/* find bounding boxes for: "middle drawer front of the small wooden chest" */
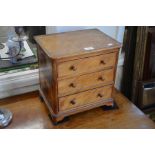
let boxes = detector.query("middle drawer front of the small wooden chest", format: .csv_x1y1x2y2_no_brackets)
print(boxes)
58,68,114,96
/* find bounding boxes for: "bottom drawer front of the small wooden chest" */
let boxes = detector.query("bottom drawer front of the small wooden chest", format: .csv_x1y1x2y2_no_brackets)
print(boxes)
59,85,112,111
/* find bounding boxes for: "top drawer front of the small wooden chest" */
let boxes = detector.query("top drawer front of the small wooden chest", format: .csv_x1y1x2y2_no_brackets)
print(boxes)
58,52,117,77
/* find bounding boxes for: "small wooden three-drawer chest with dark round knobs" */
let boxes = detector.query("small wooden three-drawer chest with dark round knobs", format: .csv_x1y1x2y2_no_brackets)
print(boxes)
35,29,120,123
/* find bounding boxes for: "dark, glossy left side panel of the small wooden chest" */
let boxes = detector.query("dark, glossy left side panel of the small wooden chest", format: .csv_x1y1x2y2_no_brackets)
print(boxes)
38,47,58,113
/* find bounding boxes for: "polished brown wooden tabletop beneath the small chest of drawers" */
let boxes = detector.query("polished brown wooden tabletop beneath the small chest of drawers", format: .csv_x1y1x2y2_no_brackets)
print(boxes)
0,91,155,129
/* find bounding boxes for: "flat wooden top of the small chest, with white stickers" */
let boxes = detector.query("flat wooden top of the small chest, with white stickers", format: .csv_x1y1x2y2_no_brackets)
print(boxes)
35,29,121,59
